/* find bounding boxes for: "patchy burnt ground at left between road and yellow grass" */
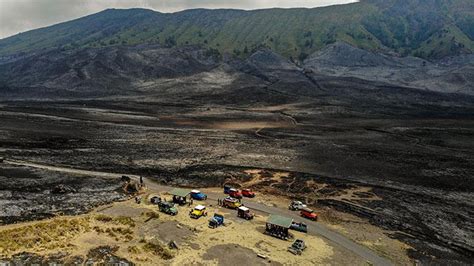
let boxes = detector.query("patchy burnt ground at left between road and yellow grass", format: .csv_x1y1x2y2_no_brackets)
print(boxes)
0,165,127,224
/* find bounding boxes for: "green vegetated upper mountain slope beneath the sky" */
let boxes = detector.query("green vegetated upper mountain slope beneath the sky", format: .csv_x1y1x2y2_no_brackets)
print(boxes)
0,0,474,60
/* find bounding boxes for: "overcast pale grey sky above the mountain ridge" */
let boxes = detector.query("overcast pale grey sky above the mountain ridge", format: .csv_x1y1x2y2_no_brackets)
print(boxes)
0,0,356,38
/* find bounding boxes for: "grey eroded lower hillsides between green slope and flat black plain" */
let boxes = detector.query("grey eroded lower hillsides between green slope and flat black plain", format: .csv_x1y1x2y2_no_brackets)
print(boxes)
0,42,474,98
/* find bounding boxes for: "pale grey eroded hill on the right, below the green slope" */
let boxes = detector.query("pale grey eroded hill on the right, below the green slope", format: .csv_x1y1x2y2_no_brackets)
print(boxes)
304,43,474,95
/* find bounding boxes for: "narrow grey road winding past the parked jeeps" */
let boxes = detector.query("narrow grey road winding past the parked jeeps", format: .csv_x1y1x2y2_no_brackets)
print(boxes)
4,160,393,265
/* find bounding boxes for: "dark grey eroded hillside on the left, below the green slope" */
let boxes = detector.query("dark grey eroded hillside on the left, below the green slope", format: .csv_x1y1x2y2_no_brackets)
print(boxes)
0,46,218,97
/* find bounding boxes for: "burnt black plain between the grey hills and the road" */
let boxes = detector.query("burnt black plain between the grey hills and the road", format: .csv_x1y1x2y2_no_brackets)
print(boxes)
0,93,474,262
